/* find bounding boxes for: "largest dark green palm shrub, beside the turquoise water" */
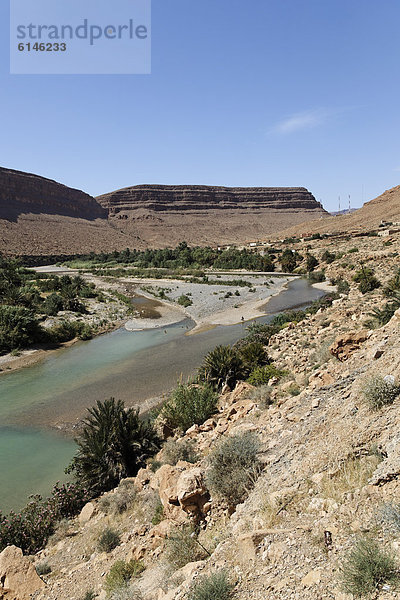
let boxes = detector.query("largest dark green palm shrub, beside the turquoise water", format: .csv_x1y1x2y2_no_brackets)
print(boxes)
69,398,160,496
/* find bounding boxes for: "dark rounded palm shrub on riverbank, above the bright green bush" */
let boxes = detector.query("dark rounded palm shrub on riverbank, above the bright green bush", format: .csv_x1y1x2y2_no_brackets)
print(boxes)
199,345,246,390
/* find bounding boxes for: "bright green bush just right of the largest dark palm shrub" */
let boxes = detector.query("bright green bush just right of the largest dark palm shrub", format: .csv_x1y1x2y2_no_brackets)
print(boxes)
161,383,218,431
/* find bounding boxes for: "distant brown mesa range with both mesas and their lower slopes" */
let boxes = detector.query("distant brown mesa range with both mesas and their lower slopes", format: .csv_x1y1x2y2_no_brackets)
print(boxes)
0,168,328,255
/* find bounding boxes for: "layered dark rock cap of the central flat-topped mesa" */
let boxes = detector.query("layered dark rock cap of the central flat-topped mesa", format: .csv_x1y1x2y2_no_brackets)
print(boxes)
97,185,326,218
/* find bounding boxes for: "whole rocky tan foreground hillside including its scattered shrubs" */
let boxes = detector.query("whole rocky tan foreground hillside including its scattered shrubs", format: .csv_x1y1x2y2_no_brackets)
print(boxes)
0,234,400,600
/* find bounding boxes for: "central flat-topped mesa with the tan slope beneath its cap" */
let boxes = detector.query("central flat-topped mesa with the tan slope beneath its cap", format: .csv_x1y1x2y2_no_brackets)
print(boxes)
97,185,328,247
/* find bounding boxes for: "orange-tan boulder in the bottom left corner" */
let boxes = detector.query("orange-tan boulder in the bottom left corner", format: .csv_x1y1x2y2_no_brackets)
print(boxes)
0,546,45,600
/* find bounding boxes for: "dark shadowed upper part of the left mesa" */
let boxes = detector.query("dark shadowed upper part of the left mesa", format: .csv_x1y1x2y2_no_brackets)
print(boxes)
0,167,107,221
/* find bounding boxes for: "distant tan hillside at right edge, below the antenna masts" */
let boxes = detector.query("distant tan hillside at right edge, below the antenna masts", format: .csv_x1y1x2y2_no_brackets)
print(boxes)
276,185,400,237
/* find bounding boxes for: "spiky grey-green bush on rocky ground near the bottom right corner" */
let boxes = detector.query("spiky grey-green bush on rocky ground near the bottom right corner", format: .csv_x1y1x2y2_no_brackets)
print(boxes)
340,538,399,598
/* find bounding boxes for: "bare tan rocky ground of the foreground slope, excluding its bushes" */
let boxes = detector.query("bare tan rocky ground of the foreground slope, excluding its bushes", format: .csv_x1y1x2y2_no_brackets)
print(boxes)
0,235,400,600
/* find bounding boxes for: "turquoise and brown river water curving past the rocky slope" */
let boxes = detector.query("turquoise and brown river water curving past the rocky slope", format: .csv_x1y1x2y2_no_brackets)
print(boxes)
0,279,324,513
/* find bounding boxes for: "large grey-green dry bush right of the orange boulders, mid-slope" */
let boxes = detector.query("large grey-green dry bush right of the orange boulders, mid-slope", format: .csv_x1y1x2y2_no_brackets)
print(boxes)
207,432,261,506
